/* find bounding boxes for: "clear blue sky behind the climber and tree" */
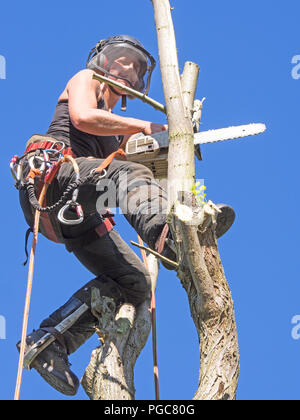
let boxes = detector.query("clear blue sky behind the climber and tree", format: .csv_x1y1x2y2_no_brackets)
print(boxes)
0,0,300,400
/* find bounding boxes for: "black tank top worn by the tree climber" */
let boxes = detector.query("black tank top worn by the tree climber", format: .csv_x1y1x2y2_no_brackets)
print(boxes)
46,99,123,158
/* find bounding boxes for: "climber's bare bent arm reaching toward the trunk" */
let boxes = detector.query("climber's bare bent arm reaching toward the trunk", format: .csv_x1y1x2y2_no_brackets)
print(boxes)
67,70,166,136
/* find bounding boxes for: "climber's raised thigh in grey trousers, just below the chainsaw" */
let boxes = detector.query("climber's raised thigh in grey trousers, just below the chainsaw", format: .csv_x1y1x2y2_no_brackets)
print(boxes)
52,158,167,248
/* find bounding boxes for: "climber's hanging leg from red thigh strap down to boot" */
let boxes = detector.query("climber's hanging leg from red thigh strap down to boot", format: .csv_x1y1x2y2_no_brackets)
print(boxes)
17,227,151,395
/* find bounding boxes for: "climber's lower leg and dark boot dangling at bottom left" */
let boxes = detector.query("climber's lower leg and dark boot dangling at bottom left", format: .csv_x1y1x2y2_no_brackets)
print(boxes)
17,275,123,395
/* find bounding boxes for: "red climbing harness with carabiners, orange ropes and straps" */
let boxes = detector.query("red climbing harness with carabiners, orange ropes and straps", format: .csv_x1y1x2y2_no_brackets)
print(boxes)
10,135,159,400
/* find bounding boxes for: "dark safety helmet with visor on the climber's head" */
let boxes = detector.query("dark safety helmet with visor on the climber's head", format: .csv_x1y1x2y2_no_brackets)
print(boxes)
86,35,156,97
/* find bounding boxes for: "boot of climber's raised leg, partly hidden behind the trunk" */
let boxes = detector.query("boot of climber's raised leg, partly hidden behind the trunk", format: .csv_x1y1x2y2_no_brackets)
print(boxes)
155,204,235,270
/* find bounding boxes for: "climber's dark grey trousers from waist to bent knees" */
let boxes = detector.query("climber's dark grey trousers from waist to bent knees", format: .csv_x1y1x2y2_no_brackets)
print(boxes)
20,158,167,305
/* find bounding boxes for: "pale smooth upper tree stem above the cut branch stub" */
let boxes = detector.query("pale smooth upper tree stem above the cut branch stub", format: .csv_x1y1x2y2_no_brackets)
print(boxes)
152,0,195,212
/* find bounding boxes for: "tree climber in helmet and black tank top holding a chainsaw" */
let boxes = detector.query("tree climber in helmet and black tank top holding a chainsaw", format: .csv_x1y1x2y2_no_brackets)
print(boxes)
17,35,234,395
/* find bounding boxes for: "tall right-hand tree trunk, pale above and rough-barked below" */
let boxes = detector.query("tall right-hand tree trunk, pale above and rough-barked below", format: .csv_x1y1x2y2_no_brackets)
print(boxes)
152,0,239,400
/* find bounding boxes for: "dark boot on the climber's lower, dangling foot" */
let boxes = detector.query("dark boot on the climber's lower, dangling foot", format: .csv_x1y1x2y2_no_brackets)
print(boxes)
17,329,79,395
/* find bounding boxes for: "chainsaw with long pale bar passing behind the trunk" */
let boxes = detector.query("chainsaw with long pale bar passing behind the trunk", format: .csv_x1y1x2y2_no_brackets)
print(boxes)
125,124,266,179
